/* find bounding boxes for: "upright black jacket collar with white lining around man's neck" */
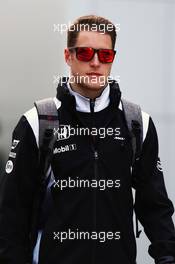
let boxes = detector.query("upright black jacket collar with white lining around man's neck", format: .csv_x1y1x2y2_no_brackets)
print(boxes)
57,77,121,113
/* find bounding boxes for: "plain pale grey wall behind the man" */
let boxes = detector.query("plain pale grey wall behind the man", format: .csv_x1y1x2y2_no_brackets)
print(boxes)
0,0,175,264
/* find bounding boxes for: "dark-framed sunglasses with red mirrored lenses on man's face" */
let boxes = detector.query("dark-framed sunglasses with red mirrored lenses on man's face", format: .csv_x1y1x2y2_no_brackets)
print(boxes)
69,47,116,63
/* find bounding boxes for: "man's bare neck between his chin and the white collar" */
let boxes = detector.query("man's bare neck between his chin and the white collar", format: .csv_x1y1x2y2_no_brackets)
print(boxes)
70,83,107,99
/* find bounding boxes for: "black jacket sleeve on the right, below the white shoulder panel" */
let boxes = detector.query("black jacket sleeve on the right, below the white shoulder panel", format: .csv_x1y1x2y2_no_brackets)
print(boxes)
133,118,175,264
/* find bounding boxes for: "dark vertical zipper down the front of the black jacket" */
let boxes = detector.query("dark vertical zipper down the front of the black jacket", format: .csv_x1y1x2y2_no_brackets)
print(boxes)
90,99,99,264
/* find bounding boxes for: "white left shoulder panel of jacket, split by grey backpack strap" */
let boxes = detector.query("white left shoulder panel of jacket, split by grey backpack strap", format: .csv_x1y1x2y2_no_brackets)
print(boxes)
23,97,61,147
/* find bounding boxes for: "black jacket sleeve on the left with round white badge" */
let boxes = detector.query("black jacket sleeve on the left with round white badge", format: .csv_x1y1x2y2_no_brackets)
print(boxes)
0,116,38,264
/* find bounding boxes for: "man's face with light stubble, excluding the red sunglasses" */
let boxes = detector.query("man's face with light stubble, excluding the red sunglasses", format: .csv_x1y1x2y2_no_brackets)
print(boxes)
65,31,112,91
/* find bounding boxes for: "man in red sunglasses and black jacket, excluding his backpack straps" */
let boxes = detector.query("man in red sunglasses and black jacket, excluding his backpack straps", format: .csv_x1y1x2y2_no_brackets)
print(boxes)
0,16,175,264
